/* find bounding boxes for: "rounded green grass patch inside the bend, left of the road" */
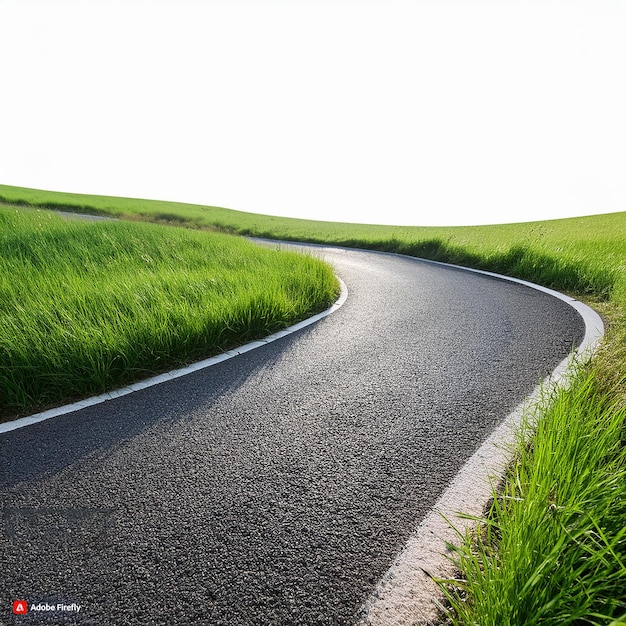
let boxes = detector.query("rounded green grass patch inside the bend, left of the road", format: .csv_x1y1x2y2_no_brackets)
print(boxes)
0,206,338,418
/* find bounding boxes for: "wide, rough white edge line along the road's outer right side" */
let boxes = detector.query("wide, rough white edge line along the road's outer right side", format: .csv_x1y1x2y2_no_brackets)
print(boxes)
358,264,604,626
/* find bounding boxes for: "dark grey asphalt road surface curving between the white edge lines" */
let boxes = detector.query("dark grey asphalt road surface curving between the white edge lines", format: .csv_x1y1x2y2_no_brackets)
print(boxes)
0,249,584,626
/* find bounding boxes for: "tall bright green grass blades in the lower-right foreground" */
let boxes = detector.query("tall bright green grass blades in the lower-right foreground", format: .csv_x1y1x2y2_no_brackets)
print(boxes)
443,371,626,626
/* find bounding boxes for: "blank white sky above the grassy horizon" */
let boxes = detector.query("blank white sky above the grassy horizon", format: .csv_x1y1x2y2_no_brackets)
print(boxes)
0,0,626,225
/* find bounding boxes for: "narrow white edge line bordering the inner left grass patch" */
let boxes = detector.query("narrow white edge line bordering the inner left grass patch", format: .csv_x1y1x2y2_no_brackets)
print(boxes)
0,278,348,433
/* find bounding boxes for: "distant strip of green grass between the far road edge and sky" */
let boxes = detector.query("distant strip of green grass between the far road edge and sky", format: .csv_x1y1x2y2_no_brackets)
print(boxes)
0,185,626,300
